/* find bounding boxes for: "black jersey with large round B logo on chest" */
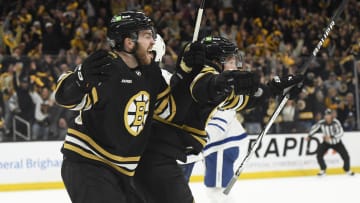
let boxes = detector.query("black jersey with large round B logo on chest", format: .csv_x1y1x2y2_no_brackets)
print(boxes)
56,53,171,176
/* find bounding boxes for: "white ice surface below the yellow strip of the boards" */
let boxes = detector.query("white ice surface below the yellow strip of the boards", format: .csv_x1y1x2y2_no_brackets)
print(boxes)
0,174,360,203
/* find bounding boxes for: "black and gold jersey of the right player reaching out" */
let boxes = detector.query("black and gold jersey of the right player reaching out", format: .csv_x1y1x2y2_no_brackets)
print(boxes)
148,65,249,161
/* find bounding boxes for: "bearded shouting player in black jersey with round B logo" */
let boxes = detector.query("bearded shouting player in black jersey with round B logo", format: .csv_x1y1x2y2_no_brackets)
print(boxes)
56,11,205,203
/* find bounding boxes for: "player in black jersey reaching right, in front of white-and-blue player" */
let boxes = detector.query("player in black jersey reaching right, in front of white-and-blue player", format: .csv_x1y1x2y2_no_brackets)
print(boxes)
135,37,302,203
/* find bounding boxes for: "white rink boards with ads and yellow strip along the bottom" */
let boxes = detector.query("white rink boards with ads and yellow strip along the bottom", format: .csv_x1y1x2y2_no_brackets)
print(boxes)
0,133,360,191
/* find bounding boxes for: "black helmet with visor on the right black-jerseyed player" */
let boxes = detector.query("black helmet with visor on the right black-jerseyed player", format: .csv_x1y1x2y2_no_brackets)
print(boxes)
201,36,242,67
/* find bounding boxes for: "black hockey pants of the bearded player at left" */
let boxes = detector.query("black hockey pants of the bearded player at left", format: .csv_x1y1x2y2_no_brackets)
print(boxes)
61,158,143,203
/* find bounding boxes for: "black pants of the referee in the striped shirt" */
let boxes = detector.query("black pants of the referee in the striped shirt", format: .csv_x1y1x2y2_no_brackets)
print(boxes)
316,141,350,171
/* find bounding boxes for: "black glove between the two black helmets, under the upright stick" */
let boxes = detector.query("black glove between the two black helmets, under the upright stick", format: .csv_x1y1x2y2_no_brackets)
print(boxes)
180,41,206,74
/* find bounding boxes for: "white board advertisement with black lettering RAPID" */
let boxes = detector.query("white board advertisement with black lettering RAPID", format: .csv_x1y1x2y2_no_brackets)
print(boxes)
193,132,360,176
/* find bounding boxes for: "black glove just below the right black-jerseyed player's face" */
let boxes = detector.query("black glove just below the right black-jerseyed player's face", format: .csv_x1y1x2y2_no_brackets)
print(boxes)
232,71,260,96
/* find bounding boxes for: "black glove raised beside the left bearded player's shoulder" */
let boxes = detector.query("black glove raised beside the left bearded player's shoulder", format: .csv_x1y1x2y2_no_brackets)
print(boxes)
75,50,112,92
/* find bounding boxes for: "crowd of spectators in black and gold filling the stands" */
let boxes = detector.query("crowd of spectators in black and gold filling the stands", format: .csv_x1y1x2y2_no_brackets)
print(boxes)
0,0,360,140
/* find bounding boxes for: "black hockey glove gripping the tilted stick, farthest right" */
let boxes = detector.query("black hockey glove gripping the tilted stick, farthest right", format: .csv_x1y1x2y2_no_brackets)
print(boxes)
268,75,304,99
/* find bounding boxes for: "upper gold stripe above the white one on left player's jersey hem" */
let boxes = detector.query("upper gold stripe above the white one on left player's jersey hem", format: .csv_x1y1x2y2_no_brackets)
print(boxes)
68,128,140,162
